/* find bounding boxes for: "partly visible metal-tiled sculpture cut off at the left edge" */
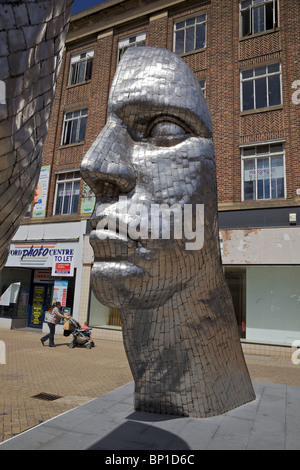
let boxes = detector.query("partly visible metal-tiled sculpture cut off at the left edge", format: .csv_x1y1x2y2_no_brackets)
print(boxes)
0,0,73,269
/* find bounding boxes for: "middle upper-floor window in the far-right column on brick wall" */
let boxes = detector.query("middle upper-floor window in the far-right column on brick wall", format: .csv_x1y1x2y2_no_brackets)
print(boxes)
241,63,282,111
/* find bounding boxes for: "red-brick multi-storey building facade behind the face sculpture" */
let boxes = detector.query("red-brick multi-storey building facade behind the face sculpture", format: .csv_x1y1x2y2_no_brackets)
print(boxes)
1,0,300,345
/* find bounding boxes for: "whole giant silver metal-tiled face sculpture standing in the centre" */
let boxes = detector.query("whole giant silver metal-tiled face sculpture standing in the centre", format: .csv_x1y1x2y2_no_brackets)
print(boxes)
82,47,254,417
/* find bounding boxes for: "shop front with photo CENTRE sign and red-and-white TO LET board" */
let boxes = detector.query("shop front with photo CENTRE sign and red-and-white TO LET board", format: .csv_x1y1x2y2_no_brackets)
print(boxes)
0,224,84,329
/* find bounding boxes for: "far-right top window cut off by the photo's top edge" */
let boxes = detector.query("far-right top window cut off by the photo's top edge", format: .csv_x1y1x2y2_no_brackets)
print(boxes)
240,0,278,37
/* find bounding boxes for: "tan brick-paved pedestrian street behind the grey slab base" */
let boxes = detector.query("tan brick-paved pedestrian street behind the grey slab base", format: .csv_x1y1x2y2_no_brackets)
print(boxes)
0,329,300,442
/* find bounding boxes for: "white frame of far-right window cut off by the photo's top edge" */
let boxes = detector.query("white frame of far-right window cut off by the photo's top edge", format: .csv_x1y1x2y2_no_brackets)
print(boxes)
240,0,279,38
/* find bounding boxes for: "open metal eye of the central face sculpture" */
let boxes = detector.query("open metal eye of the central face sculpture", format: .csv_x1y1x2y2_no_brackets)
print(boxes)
146,117,192,147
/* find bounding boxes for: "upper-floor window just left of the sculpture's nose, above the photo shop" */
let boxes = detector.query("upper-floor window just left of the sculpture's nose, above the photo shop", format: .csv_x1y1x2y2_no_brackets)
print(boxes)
54,171,81,215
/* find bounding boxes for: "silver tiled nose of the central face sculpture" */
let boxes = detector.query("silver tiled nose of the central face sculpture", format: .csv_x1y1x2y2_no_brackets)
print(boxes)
81,121,136,196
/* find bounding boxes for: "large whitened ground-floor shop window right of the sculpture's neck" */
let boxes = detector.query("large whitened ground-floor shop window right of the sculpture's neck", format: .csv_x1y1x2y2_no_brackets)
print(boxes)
224,265,300,346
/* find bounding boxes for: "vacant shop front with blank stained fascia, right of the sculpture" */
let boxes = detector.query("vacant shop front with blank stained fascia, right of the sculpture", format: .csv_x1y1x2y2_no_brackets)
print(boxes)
220,227,300,347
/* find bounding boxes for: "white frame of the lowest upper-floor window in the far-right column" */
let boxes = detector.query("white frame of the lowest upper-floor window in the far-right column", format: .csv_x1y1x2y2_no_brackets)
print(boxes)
240,140,287,201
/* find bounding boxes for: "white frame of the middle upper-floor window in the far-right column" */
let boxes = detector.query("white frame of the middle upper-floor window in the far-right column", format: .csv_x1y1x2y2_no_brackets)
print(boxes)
240,62,283,112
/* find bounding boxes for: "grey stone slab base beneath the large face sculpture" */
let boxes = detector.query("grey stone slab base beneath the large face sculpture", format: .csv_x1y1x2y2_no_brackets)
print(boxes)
0,382,300,452
